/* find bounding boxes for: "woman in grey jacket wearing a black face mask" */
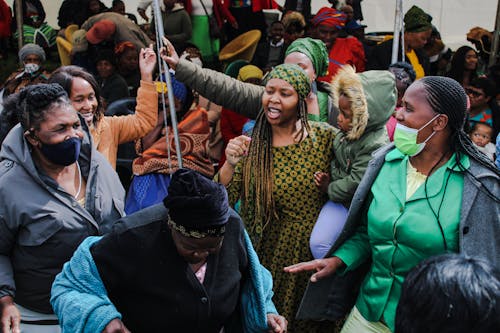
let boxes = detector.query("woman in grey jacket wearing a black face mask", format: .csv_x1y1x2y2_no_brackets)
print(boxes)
0,84,124,333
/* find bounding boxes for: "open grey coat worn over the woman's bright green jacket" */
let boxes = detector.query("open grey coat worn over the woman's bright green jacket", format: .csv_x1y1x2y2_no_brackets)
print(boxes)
297,144,500,320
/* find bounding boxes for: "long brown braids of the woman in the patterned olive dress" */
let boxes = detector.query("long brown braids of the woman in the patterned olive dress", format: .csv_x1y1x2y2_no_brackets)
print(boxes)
241,65,310,242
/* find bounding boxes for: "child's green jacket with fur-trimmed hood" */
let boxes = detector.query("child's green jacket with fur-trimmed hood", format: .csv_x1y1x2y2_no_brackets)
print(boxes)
328,66,397,207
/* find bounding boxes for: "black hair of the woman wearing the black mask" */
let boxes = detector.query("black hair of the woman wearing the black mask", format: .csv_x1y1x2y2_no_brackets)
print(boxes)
18,83,69,130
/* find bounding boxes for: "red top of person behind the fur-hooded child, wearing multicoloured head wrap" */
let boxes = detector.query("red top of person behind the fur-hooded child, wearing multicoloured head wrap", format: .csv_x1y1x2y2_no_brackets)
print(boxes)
318,37,366,83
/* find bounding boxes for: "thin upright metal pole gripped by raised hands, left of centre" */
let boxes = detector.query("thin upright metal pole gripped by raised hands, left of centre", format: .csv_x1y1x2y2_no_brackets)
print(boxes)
153,0,182,169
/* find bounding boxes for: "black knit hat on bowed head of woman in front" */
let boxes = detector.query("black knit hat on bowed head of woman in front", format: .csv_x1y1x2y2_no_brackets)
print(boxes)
163,169,229,238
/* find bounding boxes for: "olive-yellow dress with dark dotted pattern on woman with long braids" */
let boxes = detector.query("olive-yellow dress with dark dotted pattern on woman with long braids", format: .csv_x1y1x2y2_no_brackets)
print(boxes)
228,122,336,332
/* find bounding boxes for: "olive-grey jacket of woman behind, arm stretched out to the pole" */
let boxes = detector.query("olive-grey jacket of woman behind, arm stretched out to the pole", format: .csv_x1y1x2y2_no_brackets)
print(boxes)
175,59,338,126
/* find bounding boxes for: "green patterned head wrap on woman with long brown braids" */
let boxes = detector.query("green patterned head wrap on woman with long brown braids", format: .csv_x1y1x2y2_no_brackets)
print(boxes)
264,64,311,99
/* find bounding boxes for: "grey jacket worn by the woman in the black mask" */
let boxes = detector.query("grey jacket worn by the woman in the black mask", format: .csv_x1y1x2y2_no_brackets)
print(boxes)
0,125,125,313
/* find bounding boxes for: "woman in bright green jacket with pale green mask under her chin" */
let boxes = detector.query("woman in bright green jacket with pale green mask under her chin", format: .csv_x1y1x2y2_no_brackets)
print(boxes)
285,76,500,333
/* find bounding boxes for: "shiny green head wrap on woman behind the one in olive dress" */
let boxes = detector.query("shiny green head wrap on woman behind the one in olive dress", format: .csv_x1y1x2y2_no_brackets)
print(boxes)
285,37,328,76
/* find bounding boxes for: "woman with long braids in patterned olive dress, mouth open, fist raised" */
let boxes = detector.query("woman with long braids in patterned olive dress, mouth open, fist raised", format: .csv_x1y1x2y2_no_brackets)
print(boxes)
219,64,336,332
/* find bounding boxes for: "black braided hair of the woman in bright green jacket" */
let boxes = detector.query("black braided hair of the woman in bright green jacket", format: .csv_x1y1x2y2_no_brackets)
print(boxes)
418,76,500,202
